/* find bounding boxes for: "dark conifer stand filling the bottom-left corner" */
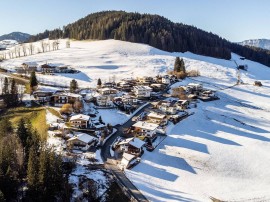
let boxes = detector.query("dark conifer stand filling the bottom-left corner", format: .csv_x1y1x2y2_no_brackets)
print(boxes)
0,118,71,201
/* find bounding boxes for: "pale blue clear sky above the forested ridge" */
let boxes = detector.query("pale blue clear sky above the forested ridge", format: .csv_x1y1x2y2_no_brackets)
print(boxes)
0,0,270,41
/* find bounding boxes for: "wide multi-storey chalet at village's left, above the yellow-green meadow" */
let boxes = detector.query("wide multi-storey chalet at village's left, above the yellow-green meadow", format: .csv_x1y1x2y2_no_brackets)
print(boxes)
52,92,82,107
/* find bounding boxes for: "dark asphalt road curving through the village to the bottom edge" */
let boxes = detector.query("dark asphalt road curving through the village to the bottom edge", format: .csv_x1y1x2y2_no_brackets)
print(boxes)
101,104,150,202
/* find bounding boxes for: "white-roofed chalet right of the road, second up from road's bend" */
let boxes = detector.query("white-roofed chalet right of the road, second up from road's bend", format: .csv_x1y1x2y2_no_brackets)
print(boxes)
132,121,159,138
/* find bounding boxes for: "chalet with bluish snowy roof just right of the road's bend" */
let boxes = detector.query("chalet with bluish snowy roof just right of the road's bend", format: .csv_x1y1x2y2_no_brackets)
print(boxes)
118,137,145,155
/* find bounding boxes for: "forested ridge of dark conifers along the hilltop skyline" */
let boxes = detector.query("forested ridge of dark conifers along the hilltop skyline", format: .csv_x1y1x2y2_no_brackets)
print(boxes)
30,11,270,66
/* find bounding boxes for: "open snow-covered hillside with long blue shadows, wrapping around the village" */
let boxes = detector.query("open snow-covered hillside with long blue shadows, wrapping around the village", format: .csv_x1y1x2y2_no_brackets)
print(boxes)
1,40,270,201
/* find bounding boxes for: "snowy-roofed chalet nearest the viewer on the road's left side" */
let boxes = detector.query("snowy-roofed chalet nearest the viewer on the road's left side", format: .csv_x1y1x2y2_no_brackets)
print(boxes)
67,133,97,151
